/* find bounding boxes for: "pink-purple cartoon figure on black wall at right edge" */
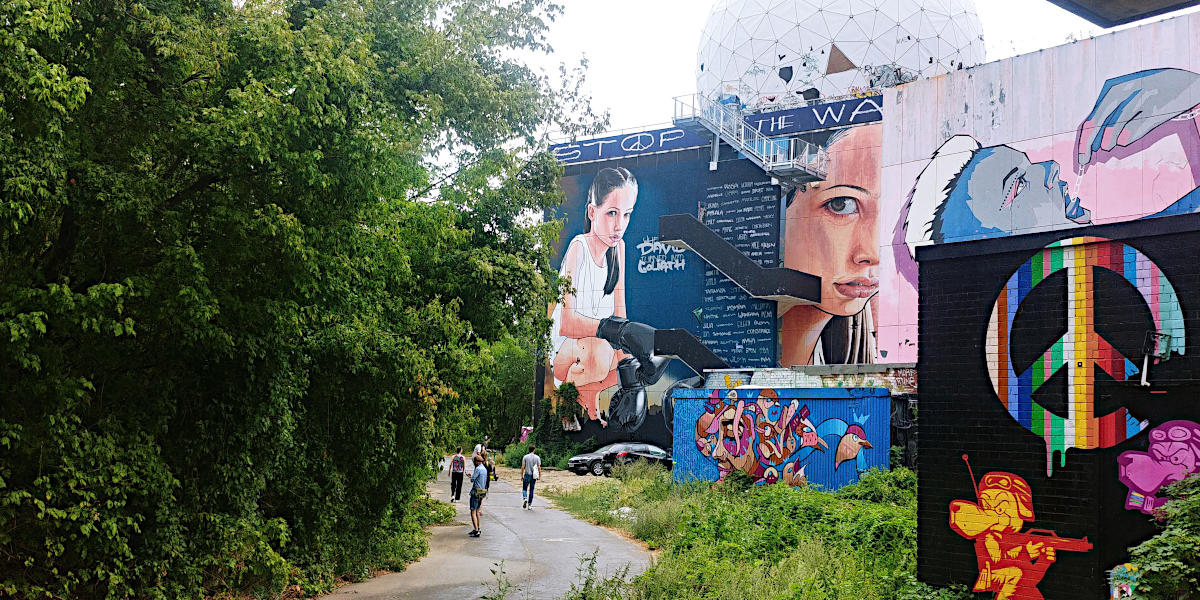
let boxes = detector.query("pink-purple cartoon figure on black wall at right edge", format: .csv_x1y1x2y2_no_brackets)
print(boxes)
1117,421,1200,515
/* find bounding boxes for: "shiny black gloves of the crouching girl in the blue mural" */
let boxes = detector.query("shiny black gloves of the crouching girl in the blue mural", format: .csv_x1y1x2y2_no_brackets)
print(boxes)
596,317,671,431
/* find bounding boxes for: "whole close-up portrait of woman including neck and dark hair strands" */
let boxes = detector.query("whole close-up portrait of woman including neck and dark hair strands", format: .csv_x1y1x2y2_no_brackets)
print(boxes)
780,124,883,367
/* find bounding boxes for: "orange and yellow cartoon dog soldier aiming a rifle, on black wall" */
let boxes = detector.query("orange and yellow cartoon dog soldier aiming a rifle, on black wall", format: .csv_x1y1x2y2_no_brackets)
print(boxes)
950,470,1092,600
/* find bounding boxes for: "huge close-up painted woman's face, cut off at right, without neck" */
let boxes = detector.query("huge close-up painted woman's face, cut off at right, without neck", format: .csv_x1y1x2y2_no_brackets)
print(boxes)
784,125,883,317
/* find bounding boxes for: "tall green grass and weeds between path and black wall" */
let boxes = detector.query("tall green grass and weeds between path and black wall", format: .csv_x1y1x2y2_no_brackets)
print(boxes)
554,464,971,600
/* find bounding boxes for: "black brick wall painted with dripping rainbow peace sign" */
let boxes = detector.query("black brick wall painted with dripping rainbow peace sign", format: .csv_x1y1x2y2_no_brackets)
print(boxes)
918,215,1200,600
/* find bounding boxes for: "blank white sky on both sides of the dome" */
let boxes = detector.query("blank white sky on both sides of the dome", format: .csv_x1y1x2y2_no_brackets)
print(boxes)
536,0,1200,132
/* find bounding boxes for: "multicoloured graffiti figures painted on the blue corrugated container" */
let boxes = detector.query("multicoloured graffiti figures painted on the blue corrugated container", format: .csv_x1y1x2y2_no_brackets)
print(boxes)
696,389,874,486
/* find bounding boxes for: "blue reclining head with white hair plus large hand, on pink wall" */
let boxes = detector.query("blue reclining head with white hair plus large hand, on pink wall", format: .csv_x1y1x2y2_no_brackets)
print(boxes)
898,68,1200,251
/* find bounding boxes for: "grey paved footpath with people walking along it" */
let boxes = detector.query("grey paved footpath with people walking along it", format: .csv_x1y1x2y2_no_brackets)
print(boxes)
323,470,650,600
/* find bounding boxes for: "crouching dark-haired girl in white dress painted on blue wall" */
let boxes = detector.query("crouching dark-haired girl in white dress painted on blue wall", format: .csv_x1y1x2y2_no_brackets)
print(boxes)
551,168,637,420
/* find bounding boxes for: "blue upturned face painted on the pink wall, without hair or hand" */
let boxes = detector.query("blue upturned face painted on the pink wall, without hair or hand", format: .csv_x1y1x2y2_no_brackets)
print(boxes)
956,145,1087,232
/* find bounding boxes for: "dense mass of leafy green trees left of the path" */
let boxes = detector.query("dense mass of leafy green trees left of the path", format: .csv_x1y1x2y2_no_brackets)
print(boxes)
0,0,600,599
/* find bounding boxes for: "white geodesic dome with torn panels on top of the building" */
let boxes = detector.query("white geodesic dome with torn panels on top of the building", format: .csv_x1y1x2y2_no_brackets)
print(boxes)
696,0,984,108
